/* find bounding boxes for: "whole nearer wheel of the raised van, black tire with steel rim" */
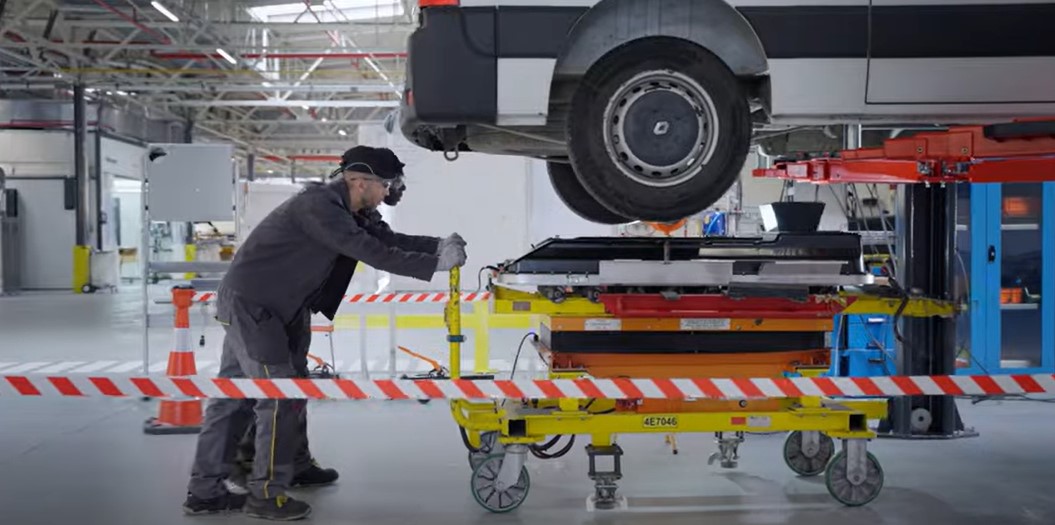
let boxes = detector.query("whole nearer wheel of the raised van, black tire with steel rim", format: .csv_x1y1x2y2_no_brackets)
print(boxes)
568,38,751,221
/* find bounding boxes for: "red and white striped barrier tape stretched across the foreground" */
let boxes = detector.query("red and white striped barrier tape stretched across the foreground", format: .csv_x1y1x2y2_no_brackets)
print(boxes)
0,374,1055,401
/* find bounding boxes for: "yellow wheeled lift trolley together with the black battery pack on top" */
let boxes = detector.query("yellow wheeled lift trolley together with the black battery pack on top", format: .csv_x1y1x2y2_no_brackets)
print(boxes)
447,233,886,512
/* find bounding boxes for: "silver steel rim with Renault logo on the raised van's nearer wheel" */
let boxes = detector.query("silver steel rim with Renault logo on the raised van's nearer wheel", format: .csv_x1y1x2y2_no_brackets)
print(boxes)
603,71,720,188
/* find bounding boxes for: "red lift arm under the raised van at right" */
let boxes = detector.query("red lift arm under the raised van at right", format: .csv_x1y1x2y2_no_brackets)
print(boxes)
754,118,1055,183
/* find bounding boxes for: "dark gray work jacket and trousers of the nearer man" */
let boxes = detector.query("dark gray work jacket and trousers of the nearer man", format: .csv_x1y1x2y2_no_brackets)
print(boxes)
188,179,440,499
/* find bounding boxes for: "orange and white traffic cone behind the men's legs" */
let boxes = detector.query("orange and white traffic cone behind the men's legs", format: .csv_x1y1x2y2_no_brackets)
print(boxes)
142,287,202,435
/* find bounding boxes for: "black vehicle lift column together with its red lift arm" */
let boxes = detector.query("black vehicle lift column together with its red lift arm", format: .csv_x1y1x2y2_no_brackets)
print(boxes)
754,118,1055,439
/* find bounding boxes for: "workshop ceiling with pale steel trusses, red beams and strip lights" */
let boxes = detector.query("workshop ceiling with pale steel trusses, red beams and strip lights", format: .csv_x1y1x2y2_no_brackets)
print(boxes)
0,0,417,170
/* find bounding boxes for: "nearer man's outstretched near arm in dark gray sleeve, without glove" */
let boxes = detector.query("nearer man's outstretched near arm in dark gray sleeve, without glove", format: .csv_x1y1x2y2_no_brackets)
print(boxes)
290,189,439,280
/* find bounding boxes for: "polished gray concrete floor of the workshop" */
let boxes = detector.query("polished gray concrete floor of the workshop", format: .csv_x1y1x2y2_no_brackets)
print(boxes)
0,293,1055,525
